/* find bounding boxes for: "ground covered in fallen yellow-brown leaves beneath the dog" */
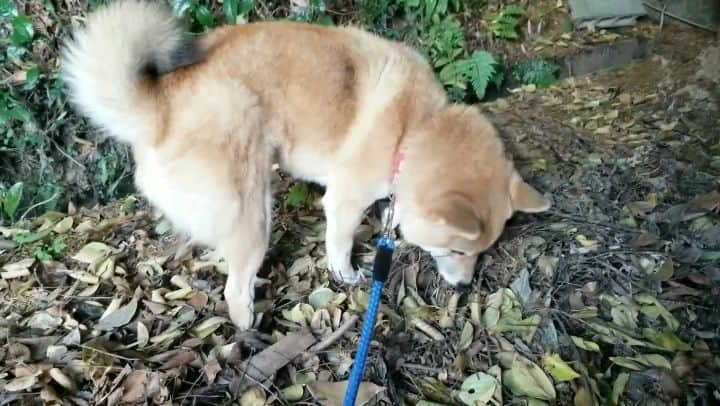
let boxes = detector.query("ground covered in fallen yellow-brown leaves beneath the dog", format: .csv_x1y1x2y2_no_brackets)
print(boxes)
0,21,720,405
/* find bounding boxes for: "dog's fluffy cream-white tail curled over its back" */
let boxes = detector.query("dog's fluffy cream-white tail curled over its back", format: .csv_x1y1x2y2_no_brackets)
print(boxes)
62,0,197,143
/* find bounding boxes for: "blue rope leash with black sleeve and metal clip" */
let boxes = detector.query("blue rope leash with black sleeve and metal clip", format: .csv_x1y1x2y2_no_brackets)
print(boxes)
343,199,395,406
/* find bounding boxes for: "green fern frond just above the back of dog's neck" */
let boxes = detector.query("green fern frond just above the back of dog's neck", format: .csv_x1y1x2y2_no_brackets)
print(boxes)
440,51,504,100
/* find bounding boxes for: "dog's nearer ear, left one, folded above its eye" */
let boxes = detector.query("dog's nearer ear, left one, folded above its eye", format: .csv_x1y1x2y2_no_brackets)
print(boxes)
427,193,483,240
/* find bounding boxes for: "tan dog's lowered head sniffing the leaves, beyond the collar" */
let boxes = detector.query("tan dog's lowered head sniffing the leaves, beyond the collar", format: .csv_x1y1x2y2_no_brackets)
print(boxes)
397,106,550,287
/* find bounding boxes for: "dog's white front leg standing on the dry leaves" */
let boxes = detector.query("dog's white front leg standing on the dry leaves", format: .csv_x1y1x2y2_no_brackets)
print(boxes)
322,185,372,284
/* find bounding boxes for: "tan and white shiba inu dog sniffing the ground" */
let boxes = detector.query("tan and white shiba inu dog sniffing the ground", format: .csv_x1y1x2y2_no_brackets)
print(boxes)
62,0,550,329
